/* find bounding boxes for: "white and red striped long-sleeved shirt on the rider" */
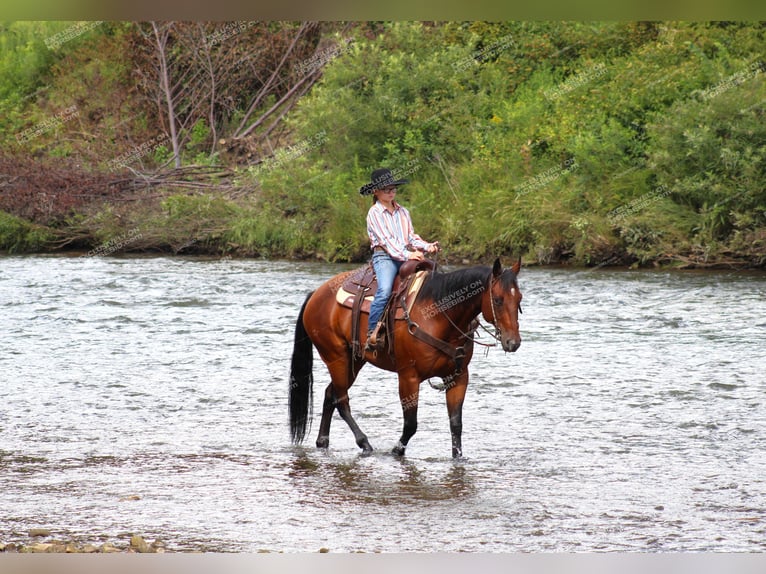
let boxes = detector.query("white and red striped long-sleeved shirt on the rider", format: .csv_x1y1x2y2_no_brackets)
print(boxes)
367,201,431,261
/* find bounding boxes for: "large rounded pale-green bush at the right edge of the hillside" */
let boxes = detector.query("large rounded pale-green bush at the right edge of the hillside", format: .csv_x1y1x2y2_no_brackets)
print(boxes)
649,65,766,243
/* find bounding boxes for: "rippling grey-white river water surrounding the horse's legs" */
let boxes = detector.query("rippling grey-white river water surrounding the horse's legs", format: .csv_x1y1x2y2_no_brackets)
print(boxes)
0,256,766,552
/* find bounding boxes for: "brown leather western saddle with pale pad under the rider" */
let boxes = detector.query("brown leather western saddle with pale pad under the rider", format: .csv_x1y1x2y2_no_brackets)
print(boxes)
335,259,436,357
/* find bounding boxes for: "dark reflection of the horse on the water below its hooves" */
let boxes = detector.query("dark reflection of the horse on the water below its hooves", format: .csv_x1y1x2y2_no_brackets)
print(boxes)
288,449,476,505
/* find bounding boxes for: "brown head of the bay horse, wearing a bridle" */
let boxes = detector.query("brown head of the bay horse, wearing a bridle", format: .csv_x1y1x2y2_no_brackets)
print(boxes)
481,259,521,353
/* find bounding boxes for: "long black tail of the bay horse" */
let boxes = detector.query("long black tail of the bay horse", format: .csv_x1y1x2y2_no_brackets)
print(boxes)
289,292,314,444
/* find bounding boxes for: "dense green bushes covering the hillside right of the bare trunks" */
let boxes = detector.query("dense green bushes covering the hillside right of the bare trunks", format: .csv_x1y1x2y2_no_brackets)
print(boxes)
263,22,766,264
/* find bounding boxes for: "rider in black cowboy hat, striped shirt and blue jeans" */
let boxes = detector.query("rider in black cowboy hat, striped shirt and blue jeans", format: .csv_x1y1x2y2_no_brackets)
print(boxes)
359,168,439,351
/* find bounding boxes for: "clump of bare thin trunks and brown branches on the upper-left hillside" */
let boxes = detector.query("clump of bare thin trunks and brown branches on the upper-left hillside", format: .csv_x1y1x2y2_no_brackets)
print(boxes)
136,22,340,168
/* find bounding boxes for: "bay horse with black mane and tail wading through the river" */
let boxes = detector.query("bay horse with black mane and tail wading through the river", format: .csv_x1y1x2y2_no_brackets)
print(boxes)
289,258,522,458
